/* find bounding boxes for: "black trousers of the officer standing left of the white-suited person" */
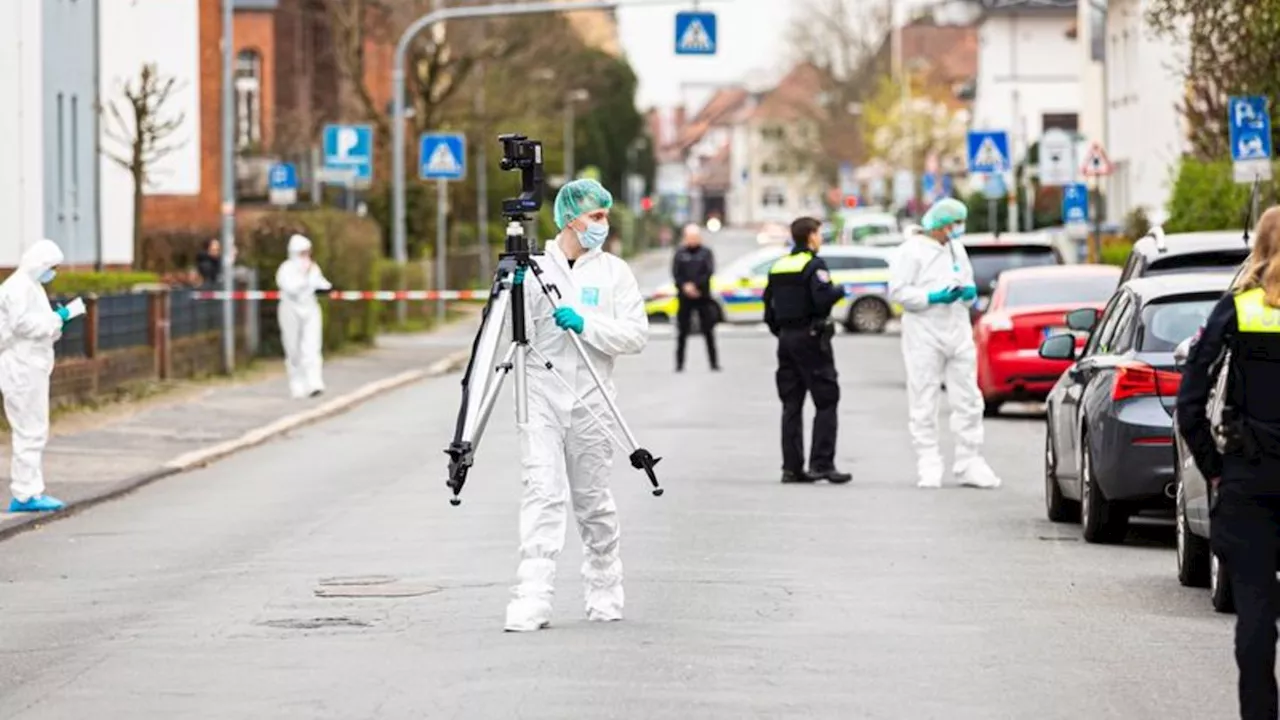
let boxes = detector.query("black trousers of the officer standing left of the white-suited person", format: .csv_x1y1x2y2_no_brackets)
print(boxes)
777,329,840,473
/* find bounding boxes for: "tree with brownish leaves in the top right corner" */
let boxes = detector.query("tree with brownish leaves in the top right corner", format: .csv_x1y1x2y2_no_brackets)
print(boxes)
1147,0,1280,161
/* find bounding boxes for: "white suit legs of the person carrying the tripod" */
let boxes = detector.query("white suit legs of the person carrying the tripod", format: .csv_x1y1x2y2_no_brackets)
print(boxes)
515,392,623,614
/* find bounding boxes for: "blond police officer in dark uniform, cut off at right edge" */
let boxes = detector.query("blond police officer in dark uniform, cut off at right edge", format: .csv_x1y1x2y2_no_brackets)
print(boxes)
1178,208,1280,720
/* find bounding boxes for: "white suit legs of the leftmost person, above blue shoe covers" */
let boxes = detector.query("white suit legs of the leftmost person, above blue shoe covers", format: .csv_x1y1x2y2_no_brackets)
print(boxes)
0,352,49,502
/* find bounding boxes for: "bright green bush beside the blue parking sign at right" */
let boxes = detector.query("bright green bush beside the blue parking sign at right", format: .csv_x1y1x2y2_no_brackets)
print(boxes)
1165,158,1265,233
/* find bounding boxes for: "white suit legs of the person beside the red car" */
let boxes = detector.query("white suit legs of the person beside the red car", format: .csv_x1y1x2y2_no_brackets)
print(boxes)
902,337,983,473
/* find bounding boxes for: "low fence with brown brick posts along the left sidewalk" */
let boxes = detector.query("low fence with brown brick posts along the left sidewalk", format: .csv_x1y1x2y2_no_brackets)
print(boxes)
50,288,257,405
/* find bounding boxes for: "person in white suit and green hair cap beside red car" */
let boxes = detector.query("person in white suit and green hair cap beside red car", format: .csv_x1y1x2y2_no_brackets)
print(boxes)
888,197,1000,488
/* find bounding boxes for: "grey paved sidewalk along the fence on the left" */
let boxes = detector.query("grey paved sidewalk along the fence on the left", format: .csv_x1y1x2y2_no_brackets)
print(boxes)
0,316,479,539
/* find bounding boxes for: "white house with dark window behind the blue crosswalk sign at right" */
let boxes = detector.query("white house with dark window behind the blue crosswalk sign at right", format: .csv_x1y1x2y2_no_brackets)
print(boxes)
973,0,1082,163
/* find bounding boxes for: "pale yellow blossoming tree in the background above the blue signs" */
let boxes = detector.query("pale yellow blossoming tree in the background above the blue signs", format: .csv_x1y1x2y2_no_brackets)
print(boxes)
863,76,969,177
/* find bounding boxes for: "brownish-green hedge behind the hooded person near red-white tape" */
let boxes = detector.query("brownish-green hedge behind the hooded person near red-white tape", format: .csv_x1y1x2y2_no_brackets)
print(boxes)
237,209,383,350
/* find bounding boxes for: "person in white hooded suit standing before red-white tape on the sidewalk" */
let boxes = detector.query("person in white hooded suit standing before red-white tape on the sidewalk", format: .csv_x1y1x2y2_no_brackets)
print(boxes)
275,234,333,397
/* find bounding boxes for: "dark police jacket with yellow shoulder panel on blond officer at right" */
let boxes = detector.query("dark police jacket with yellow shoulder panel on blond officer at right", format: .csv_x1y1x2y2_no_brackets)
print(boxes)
1176,283,1280,482
